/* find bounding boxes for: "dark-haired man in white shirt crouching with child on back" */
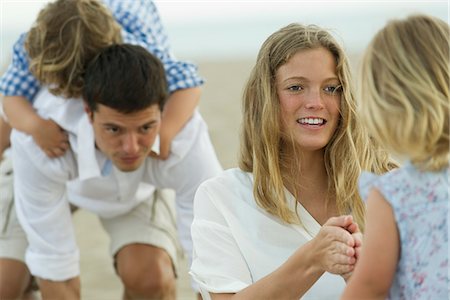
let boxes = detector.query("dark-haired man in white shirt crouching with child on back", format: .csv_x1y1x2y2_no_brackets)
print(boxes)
12,45,221,299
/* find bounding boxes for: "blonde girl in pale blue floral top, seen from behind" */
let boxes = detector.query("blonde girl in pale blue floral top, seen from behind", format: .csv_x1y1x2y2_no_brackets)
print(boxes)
342,15,450,299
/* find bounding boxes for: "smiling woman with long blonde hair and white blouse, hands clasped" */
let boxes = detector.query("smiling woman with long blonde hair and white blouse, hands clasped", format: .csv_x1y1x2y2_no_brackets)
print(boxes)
191,24,396,299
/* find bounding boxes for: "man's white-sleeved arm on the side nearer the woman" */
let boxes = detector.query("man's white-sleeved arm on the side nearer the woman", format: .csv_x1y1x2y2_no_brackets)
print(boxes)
147,113,222,259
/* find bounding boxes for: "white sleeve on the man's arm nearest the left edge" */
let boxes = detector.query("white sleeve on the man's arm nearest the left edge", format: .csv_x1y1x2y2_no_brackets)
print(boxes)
11,131,79,286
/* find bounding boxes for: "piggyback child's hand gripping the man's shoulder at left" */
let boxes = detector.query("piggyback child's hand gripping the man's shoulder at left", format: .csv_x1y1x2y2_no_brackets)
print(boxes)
32,119,69,158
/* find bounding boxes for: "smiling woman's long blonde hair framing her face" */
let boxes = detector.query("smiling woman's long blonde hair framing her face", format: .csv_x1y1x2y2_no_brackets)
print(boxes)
239,24,390,228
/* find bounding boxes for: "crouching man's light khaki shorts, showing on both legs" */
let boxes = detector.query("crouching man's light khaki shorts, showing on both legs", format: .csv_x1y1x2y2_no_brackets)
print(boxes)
0,158,182,273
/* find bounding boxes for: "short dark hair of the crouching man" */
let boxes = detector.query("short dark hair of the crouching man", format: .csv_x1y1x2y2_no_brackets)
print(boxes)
83,44,168,113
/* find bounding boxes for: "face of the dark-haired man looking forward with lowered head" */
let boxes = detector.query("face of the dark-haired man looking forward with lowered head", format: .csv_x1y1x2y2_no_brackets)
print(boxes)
85,104,161,172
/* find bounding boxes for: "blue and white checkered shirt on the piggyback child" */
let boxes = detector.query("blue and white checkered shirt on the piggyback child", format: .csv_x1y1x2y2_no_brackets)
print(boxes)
0,0,203,101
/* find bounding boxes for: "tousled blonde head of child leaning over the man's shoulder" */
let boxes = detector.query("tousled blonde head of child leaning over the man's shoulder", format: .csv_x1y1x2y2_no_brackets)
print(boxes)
25,0,121,97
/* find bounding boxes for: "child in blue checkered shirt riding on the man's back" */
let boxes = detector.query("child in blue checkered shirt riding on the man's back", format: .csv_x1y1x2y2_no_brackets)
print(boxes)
0,0,203,159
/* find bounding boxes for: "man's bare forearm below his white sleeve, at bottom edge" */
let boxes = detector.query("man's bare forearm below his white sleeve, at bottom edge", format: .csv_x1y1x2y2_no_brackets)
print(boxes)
39,277,80,300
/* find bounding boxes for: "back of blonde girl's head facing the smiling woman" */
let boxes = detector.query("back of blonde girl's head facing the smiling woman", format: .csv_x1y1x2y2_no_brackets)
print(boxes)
360,15,450,170
